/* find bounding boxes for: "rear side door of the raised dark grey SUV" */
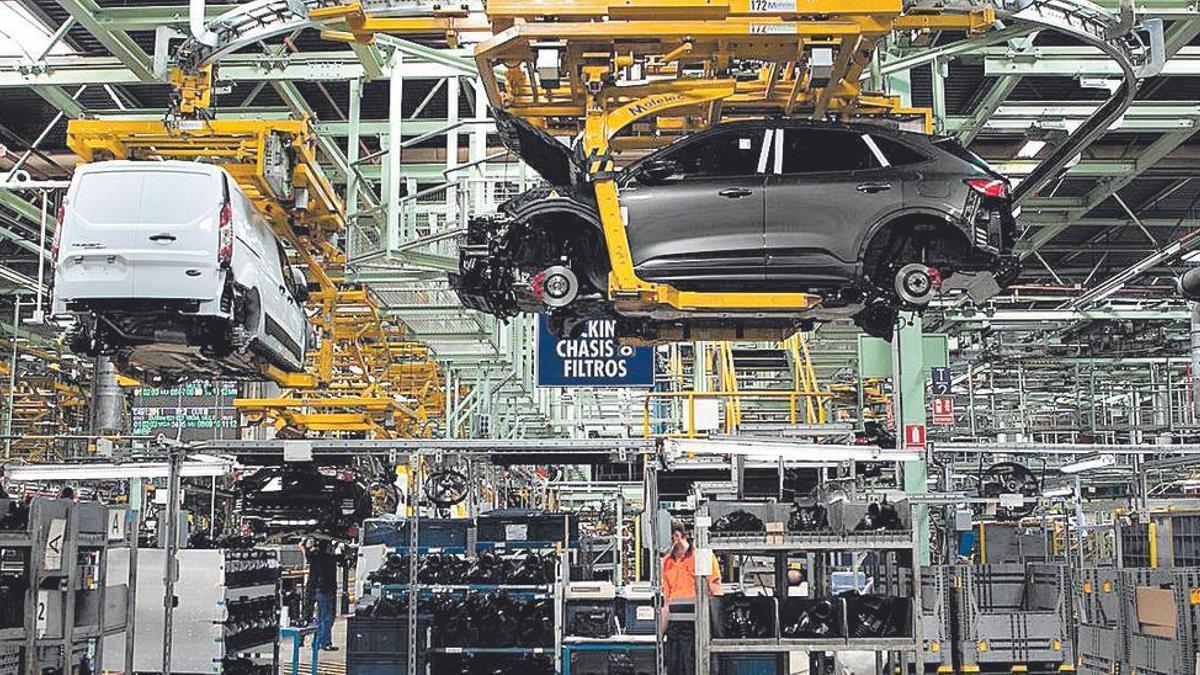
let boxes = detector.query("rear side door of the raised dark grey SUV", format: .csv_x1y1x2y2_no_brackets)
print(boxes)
764,127,904,287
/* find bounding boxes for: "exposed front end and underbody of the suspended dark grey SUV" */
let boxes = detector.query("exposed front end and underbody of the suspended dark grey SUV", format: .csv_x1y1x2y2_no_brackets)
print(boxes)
450,204,1020,344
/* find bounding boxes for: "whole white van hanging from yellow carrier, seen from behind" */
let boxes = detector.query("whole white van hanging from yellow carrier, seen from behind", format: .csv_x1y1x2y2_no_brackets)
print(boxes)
53,161,308,380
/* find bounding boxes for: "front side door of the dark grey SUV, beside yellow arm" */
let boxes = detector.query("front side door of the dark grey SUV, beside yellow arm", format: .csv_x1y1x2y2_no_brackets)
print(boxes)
620,127,766,288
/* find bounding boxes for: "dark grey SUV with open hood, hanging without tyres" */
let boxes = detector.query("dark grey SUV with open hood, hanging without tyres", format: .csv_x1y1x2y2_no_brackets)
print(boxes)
451,112,1019,339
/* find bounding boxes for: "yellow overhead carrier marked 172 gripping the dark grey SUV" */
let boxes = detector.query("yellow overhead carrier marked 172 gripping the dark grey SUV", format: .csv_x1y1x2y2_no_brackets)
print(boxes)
310,0,995,315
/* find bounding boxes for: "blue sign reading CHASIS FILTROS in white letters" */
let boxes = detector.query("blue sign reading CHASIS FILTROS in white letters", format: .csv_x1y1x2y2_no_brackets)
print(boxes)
538,315,654,387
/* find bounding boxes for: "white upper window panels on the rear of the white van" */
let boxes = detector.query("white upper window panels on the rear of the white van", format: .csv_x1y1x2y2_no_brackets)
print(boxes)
71,171,221,225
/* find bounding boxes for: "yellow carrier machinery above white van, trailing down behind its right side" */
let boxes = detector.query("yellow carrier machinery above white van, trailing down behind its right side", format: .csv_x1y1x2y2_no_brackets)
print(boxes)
67,117,445,437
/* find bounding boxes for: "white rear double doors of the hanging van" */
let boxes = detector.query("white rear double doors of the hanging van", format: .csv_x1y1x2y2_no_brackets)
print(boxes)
59,162,226,299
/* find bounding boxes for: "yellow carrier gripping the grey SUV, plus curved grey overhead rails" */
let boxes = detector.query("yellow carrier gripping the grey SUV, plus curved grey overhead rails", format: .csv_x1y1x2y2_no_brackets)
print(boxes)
157,0,1162,329
